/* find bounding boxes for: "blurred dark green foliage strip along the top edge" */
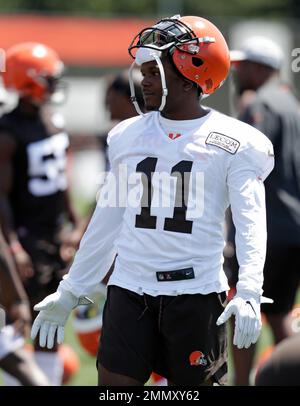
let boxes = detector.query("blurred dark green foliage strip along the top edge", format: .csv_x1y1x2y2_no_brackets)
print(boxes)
0,0,300,17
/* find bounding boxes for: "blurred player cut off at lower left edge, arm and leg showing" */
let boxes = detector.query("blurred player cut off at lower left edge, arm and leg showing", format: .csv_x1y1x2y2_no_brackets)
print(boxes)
0,225,49,386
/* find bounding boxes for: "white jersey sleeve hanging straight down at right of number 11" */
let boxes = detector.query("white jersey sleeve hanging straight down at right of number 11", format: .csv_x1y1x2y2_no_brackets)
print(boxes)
227,138,274,295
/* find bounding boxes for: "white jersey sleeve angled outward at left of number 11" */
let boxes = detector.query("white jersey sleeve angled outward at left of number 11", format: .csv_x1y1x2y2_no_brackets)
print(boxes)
60,135,125,297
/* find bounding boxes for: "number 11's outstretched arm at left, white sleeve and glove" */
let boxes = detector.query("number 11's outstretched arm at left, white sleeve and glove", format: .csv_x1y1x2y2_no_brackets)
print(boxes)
31,155,124,348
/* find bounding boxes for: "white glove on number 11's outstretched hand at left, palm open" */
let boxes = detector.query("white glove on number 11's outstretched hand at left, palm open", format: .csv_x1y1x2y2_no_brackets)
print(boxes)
31,289,93,349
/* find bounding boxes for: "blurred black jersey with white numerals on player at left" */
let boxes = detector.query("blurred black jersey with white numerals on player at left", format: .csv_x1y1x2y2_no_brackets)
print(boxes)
0,108,69,235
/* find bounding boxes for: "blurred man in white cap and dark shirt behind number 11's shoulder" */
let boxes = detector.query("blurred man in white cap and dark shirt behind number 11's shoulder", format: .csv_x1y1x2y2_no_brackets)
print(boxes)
227,36,300,385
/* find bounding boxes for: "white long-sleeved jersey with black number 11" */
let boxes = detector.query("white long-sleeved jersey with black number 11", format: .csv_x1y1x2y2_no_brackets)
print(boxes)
61,110,274,296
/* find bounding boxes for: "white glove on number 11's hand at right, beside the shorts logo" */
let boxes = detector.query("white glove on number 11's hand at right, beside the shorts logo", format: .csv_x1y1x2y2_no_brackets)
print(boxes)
217,294,273,348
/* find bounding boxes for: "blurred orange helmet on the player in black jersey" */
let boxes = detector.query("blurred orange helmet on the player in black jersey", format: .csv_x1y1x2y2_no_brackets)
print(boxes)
3,42,64,103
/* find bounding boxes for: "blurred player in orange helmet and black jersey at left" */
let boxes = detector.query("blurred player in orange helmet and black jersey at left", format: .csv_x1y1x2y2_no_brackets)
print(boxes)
0,43,81,385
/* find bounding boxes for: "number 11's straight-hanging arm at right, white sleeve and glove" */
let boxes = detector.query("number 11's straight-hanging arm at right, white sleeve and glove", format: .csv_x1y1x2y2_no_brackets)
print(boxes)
218,142,274,348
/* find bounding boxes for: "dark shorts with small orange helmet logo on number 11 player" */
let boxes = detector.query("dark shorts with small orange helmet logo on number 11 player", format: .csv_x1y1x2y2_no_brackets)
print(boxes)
97,286,227,385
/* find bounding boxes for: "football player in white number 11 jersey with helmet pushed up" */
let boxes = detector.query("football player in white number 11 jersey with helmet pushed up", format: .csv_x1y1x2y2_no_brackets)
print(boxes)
32,15,273,385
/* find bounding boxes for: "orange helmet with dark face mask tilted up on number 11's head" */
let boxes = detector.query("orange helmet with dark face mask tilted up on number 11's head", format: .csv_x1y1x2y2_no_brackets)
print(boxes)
129,15,230,95
